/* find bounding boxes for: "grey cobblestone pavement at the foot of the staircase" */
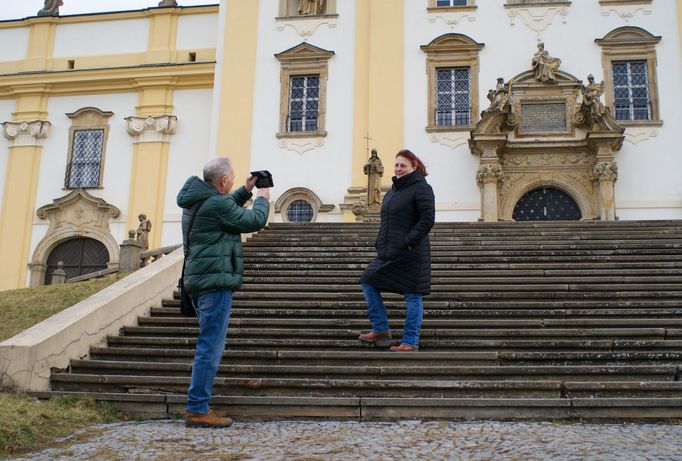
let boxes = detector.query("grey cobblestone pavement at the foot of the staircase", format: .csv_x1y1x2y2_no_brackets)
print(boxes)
6,420,682,461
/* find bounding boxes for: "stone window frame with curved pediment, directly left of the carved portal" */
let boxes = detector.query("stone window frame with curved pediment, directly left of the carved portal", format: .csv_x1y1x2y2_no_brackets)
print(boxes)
420,33,485,133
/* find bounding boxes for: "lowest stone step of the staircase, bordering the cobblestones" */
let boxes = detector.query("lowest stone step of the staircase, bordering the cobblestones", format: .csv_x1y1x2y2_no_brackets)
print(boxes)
31,391,682,421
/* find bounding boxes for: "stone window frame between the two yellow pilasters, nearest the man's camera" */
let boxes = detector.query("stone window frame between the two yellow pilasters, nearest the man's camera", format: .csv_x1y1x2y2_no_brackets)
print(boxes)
275,42,334,138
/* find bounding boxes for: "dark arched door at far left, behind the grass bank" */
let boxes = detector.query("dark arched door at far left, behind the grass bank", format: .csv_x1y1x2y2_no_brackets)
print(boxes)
45,238,109,285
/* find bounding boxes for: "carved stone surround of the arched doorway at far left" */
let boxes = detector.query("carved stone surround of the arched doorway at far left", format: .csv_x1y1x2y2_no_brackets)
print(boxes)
29,189,121,287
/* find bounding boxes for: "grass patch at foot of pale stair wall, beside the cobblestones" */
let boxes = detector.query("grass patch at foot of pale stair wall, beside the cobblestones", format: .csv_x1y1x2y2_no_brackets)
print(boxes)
0,393,117,458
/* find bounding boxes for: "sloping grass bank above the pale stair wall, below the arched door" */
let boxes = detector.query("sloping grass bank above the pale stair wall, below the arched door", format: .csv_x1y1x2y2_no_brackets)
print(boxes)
0,274,127,342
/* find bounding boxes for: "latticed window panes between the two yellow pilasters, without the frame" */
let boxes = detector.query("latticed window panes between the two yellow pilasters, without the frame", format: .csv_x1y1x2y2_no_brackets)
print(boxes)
287,75,320,132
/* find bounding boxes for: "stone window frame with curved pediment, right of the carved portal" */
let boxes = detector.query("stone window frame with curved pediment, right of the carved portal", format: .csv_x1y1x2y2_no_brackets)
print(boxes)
595,26,663,127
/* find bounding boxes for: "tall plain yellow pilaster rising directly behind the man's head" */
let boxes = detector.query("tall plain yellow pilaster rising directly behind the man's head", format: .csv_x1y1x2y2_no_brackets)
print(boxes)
215,0,259,180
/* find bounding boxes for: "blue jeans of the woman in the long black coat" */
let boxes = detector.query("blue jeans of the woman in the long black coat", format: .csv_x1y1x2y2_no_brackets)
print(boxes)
360,283,424,347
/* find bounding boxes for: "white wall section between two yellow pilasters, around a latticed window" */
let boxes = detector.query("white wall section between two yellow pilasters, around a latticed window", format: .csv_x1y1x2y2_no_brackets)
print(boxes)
251,1,355,221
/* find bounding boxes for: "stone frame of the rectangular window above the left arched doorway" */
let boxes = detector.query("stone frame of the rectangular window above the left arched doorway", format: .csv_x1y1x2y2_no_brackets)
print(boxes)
64,107,114,190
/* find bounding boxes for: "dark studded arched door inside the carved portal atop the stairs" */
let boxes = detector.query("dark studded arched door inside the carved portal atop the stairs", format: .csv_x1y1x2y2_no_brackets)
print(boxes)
512,187,582,221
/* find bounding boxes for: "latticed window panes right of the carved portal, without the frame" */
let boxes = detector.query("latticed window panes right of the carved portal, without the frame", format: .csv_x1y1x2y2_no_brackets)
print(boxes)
613,61,651,120
